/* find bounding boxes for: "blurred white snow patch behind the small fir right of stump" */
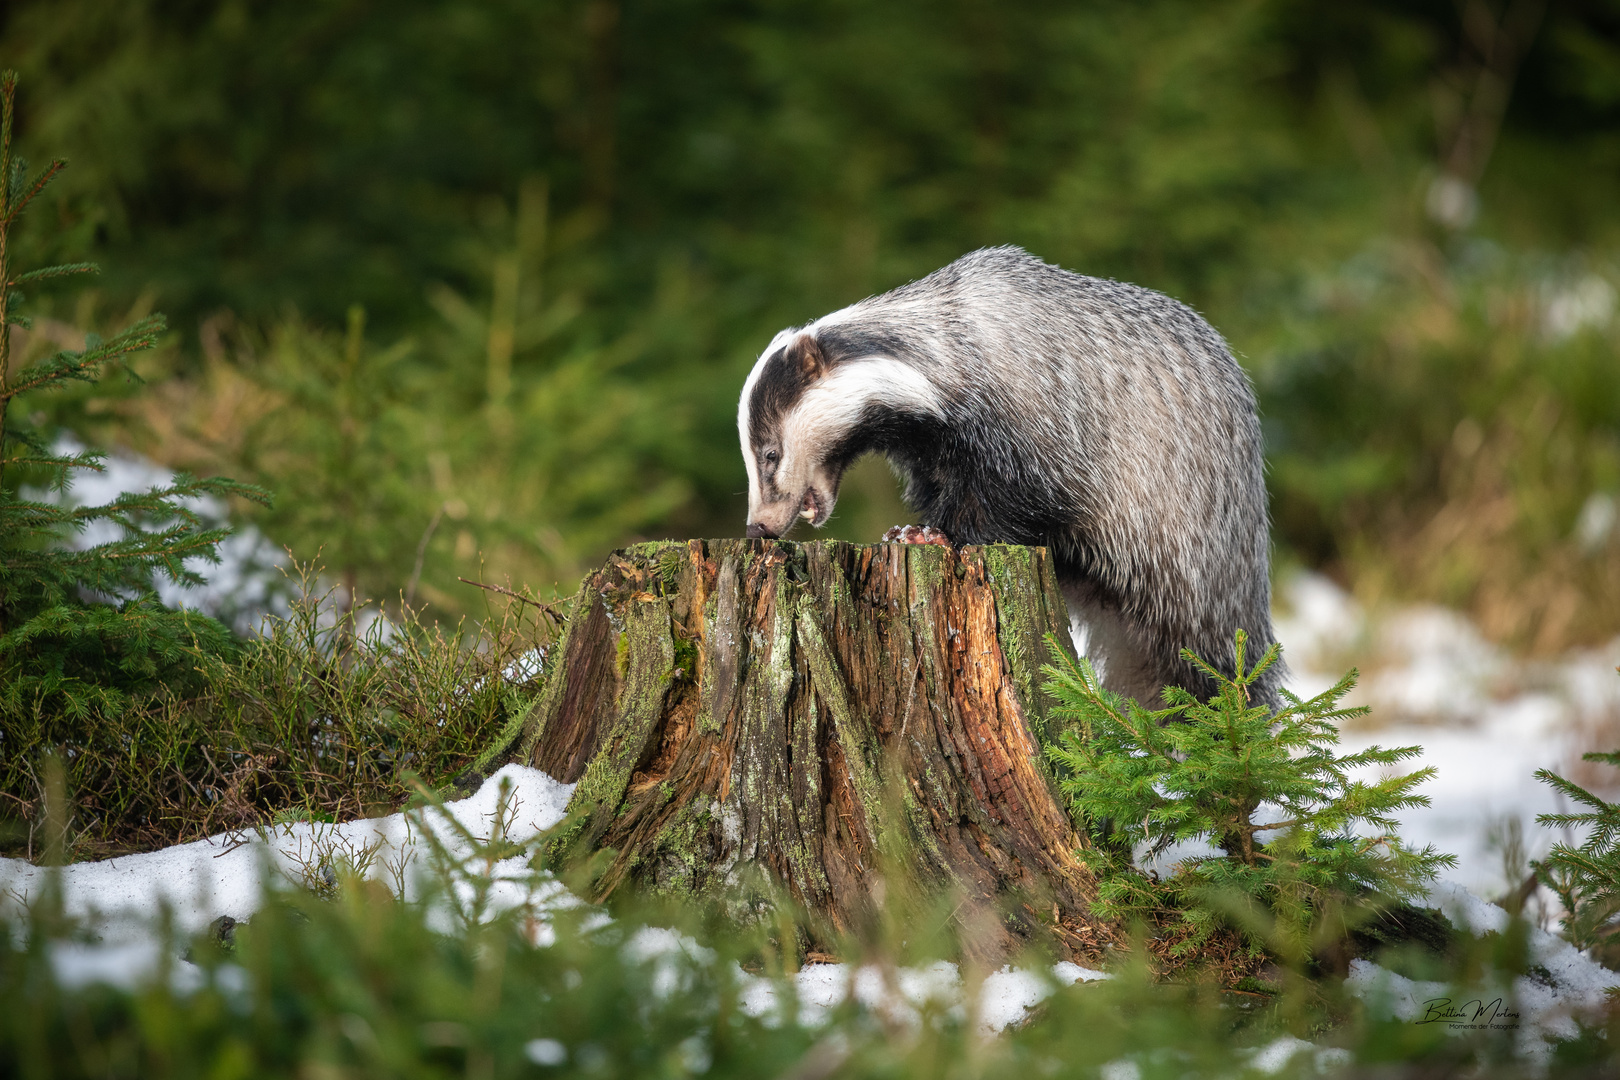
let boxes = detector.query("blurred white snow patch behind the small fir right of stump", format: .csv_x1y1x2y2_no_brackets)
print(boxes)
1277,575,1620,895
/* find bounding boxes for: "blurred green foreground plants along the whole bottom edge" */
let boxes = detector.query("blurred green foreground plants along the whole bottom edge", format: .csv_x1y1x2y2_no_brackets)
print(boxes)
0,829,1600,1080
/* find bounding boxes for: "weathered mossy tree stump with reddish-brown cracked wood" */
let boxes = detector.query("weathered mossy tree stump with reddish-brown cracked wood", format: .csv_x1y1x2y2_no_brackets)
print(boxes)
514,539,1111,962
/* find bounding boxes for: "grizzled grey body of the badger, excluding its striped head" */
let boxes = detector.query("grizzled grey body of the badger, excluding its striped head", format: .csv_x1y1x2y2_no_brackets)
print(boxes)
805,248,1272,702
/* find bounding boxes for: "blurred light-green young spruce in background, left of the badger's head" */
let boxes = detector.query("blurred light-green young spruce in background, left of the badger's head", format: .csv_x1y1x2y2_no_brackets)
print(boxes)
411,178,693,595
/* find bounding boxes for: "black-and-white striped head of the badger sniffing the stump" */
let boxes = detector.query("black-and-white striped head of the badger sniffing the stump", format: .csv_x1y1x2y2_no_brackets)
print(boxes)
737,327,940,538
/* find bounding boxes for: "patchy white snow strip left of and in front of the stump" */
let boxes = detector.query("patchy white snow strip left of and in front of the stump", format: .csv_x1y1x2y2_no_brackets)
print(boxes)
0,764,1108,1035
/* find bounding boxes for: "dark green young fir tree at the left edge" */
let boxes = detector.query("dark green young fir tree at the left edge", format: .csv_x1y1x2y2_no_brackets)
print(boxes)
0,71,266,721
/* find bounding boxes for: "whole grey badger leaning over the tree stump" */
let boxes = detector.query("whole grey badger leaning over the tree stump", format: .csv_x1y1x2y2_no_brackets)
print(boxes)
737,246,1281,708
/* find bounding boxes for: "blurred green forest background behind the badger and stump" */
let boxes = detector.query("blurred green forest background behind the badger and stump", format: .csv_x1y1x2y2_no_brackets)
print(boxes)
0,0,1620,651
